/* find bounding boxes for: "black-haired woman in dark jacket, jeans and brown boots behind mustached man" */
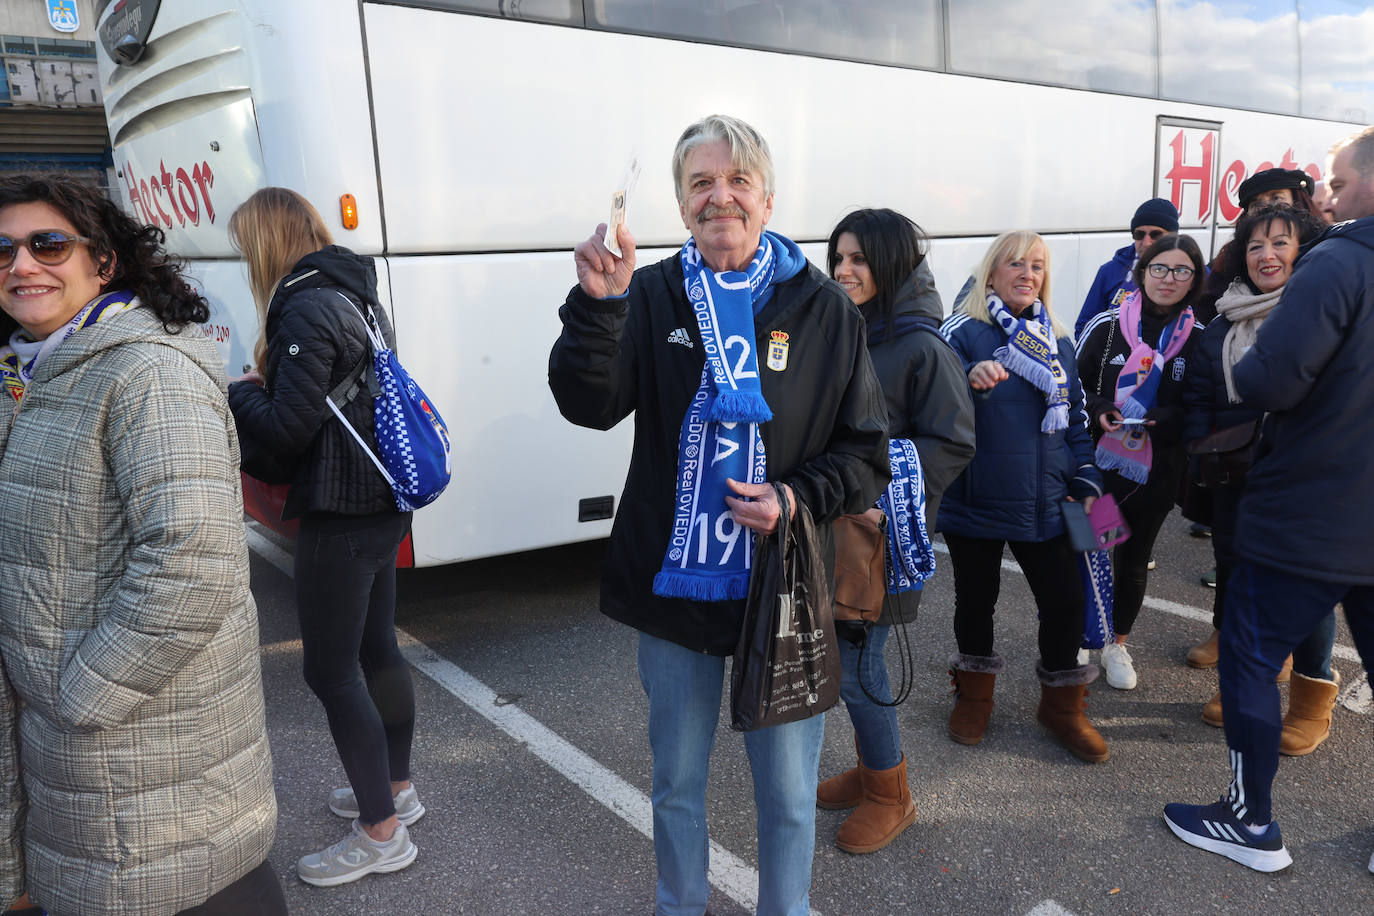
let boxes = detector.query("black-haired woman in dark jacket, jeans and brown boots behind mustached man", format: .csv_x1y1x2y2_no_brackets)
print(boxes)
816,210,973,853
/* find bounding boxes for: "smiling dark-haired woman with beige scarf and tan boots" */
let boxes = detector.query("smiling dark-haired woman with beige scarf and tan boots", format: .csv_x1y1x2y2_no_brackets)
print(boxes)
1183,203,1340,757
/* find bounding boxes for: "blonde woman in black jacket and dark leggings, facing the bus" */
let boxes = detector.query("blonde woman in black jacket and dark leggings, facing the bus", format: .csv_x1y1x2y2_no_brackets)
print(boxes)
229,188,425,886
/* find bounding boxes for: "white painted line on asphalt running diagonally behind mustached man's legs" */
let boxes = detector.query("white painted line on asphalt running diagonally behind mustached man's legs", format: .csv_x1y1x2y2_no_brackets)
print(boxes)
247,525,774,916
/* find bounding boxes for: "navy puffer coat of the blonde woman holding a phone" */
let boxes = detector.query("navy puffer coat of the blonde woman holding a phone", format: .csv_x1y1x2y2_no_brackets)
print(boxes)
938,313,1102,541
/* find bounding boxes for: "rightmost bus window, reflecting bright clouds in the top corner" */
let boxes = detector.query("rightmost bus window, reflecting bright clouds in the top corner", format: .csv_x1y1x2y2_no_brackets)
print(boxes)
1297,0,1374,124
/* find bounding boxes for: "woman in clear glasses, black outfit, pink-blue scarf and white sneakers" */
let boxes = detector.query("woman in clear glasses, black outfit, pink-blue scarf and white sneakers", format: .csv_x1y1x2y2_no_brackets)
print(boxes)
1077,233,1204,691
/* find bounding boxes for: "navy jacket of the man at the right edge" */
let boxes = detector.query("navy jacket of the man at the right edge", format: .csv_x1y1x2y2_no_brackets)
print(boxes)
1232,216,1374,585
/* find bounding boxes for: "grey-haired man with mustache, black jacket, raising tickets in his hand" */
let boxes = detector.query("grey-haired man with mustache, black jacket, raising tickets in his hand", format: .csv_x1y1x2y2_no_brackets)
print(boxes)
548,115,888,916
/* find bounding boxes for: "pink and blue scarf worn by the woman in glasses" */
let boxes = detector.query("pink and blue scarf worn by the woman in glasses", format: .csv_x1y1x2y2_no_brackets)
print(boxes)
1095,290,1194,483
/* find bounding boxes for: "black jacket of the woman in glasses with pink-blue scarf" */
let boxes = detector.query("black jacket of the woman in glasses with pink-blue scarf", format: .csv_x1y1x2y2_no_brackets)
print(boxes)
1077,304,1205,504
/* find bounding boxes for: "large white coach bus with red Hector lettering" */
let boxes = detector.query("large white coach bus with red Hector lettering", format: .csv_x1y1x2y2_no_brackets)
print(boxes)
98,0,1374,566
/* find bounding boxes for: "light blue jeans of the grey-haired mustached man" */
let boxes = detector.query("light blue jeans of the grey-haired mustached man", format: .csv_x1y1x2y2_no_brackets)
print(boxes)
639,633,826,916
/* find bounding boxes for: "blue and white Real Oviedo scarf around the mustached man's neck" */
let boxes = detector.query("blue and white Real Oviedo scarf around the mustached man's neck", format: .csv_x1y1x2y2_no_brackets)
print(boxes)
654,232,807,602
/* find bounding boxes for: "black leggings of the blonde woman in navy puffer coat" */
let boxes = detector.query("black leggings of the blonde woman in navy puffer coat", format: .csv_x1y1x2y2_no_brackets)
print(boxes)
944,531,1083,672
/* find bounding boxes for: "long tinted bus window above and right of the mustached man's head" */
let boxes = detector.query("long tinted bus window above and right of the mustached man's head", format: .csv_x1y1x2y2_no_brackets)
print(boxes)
587,0,940,67
